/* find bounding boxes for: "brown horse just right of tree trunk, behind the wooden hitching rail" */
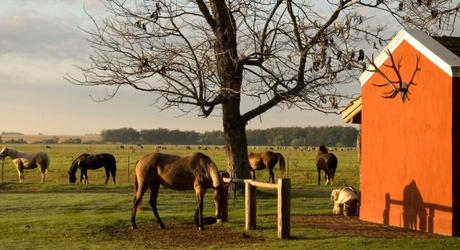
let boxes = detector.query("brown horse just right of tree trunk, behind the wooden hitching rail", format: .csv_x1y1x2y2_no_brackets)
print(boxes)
249,151,286,183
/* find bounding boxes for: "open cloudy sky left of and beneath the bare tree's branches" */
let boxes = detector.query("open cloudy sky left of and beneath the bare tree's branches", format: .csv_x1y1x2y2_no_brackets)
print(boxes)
0,0,359,135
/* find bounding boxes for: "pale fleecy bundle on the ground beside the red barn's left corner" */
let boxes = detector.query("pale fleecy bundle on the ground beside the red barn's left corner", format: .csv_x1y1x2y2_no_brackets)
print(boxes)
331,187,360,216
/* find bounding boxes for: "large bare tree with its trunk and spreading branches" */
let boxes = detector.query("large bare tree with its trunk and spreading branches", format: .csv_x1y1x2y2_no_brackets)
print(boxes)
67,0,458,178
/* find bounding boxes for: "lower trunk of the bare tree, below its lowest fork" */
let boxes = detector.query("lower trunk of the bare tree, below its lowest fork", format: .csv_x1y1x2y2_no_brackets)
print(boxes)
222,98,250,178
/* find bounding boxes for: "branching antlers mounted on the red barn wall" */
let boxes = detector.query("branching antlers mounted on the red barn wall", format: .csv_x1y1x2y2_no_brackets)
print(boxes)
368,50,420,102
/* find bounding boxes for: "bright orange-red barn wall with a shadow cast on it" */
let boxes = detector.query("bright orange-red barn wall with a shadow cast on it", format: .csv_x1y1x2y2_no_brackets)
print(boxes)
360,41,458,235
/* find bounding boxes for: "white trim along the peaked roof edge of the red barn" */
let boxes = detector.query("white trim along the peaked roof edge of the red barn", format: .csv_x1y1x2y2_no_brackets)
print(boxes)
359,29,460,86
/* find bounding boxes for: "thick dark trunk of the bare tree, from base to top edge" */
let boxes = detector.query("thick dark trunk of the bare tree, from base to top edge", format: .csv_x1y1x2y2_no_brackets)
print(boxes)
210,0,249,182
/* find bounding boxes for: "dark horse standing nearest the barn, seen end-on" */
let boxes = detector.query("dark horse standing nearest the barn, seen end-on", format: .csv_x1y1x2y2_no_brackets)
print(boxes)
316,145,338,185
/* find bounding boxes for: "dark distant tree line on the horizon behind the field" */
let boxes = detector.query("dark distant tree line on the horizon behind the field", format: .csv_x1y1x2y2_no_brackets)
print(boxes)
101,126,358,147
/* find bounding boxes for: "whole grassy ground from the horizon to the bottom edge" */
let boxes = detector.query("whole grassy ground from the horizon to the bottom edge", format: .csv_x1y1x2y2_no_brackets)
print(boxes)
0,145,460,249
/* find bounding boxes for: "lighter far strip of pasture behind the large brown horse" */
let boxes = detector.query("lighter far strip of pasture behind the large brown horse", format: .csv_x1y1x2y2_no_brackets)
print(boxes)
0,144,359,188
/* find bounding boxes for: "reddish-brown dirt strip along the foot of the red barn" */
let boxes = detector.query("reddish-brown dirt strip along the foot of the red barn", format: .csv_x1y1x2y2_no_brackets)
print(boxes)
291,215,443,239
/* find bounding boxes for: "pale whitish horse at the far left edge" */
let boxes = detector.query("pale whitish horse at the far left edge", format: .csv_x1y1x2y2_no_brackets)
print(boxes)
0,147,50,183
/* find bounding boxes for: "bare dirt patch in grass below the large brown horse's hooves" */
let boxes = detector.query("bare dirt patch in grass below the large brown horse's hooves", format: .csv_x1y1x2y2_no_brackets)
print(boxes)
105,222,264,248
